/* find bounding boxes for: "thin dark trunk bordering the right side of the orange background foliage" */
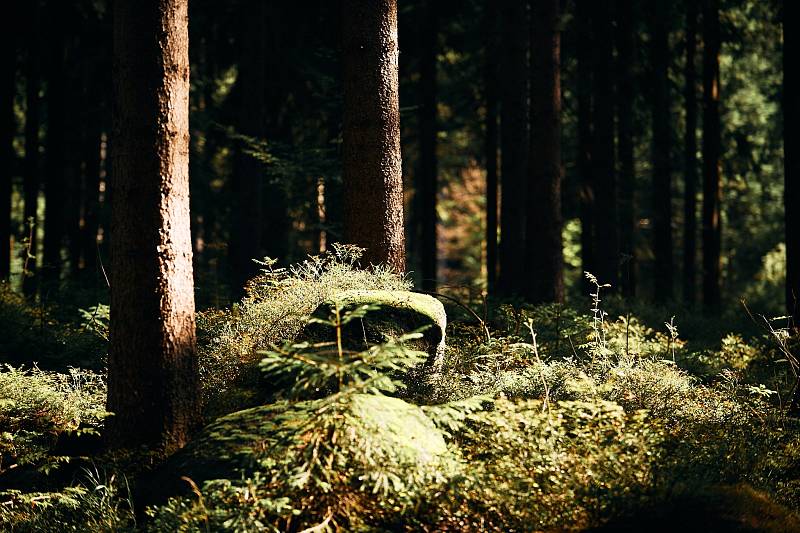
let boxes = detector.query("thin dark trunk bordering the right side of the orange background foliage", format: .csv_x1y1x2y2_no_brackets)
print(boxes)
484,0,498,296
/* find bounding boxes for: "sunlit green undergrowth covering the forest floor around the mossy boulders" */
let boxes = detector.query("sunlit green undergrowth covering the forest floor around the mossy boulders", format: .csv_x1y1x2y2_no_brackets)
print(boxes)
0,260,800,531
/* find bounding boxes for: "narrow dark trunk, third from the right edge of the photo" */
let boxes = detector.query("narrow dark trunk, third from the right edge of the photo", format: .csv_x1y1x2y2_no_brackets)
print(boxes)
683,2,697,306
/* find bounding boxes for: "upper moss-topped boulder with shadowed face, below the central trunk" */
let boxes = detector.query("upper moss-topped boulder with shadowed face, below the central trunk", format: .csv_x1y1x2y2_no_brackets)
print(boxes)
299,290,447,371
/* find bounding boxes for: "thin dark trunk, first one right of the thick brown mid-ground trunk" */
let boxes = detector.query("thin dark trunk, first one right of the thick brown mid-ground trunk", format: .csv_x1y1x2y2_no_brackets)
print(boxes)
575,0,595,294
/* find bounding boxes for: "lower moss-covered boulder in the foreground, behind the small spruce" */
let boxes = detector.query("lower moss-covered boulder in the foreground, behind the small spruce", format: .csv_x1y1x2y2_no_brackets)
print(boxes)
136,394,456,505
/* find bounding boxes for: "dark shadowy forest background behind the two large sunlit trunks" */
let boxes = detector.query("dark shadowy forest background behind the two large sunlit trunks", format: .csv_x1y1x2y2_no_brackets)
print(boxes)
2,0,785,313
